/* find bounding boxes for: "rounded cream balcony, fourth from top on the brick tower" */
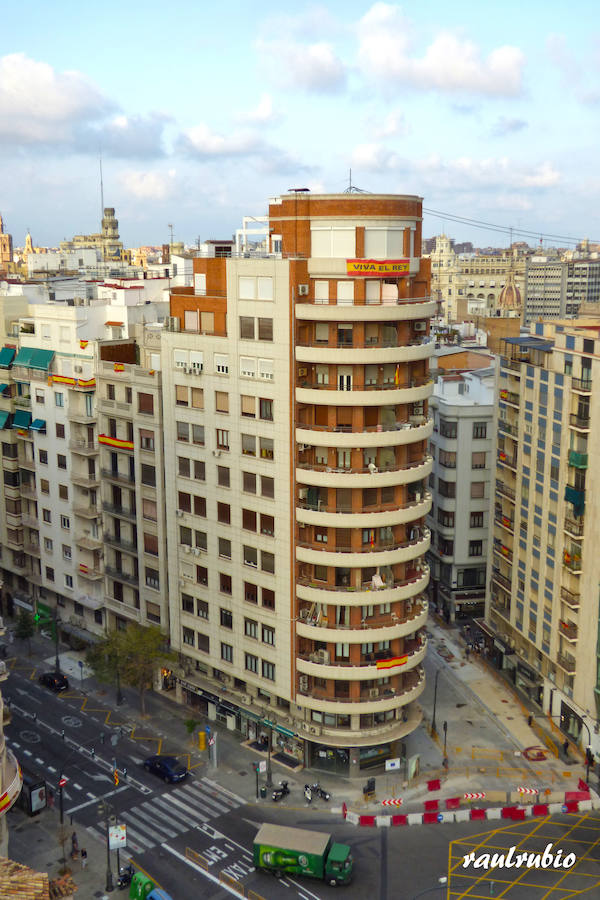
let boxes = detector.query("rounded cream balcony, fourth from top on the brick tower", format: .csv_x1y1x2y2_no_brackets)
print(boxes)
296,416,433,449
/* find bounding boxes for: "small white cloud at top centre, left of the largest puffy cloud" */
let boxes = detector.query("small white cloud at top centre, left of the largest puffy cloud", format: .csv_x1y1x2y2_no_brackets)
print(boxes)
257,38,347,94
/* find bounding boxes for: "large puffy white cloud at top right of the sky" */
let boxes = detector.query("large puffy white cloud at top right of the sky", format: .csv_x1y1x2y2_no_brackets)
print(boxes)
357,3,525,96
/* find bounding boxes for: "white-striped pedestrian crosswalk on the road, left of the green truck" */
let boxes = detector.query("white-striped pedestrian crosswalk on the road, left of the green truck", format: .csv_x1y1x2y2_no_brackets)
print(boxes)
87,779,241,853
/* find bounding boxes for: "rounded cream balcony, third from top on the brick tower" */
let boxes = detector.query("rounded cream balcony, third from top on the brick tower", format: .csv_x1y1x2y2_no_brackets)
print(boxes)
296,376,433,406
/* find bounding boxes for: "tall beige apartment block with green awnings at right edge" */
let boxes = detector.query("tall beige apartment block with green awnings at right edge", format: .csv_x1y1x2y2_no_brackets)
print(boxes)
487,318,600,753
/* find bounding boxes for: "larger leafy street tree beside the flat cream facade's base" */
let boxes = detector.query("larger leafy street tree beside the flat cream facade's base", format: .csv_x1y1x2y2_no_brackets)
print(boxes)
86,623,177,715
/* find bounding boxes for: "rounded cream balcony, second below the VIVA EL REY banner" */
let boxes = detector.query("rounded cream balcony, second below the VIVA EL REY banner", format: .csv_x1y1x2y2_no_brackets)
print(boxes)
296,340,434,366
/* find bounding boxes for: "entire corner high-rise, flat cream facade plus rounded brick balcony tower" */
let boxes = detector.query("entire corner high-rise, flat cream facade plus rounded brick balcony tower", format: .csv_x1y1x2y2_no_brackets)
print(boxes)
162,192,435,774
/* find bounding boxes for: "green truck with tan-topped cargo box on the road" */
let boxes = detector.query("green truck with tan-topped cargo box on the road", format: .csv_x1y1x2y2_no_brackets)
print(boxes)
254,824,354,887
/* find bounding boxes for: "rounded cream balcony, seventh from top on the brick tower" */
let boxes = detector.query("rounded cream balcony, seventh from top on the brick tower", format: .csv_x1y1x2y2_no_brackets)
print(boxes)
296,528,431,568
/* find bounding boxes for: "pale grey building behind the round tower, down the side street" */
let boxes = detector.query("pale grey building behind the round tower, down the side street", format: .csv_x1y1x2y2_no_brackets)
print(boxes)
428,353,494,622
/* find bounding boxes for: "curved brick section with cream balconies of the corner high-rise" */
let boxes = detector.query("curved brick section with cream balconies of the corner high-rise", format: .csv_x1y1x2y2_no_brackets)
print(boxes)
284,193,435,774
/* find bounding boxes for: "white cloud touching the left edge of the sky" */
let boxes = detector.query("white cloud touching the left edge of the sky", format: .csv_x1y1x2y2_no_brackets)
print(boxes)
0,53,113,144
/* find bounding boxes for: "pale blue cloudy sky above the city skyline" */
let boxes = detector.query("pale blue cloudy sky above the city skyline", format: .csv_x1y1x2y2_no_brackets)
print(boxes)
0,0,600,246
